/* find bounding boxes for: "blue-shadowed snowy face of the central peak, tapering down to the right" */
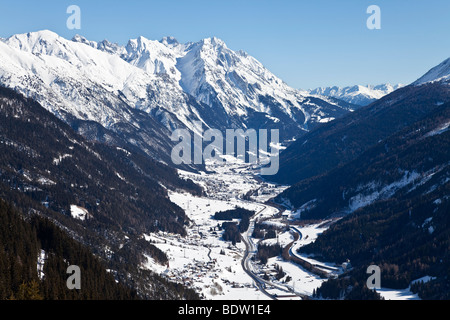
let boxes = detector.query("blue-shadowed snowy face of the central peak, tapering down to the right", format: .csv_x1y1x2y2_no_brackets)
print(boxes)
177,37,354,135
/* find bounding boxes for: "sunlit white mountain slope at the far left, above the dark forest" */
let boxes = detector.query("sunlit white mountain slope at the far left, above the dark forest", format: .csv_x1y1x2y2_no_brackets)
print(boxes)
0,31,207,128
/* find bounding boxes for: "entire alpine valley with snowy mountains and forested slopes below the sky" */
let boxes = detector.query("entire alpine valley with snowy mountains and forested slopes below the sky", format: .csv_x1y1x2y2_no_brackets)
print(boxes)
0,30,450,300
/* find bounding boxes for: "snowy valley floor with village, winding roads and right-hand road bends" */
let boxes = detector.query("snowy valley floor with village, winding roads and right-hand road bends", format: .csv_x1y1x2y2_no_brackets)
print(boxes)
142,161,418,300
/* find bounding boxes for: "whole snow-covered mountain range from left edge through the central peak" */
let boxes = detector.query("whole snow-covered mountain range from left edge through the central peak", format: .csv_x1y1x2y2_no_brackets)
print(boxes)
0,30,351,155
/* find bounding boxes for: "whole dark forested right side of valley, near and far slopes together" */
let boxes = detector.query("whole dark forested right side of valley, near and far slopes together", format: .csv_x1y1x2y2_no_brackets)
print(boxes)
285,104,450,299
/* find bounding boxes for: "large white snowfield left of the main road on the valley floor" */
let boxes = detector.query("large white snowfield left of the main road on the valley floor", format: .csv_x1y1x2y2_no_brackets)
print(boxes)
144,185,263,299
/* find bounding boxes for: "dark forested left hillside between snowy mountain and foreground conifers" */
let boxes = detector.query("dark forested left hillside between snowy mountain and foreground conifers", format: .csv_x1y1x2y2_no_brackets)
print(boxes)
0,87,202,299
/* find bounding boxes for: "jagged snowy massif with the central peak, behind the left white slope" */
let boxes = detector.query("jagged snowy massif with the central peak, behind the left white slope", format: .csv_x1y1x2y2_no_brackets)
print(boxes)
103,33,351,135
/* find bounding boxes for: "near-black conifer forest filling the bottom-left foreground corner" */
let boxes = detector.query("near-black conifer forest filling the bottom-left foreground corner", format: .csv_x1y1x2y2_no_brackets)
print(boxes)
0,200,138,300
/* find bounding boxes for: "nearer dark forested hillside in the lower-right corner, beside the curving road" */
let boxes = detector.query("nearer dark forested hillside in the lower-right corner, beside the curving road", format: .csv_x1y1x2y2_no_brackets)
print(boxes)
308,182,450,300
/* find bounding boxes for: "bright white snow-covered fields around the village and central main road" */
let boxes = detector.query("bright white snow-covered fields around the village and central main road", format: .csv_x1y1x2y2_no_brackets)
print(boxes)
143,161,323,300
